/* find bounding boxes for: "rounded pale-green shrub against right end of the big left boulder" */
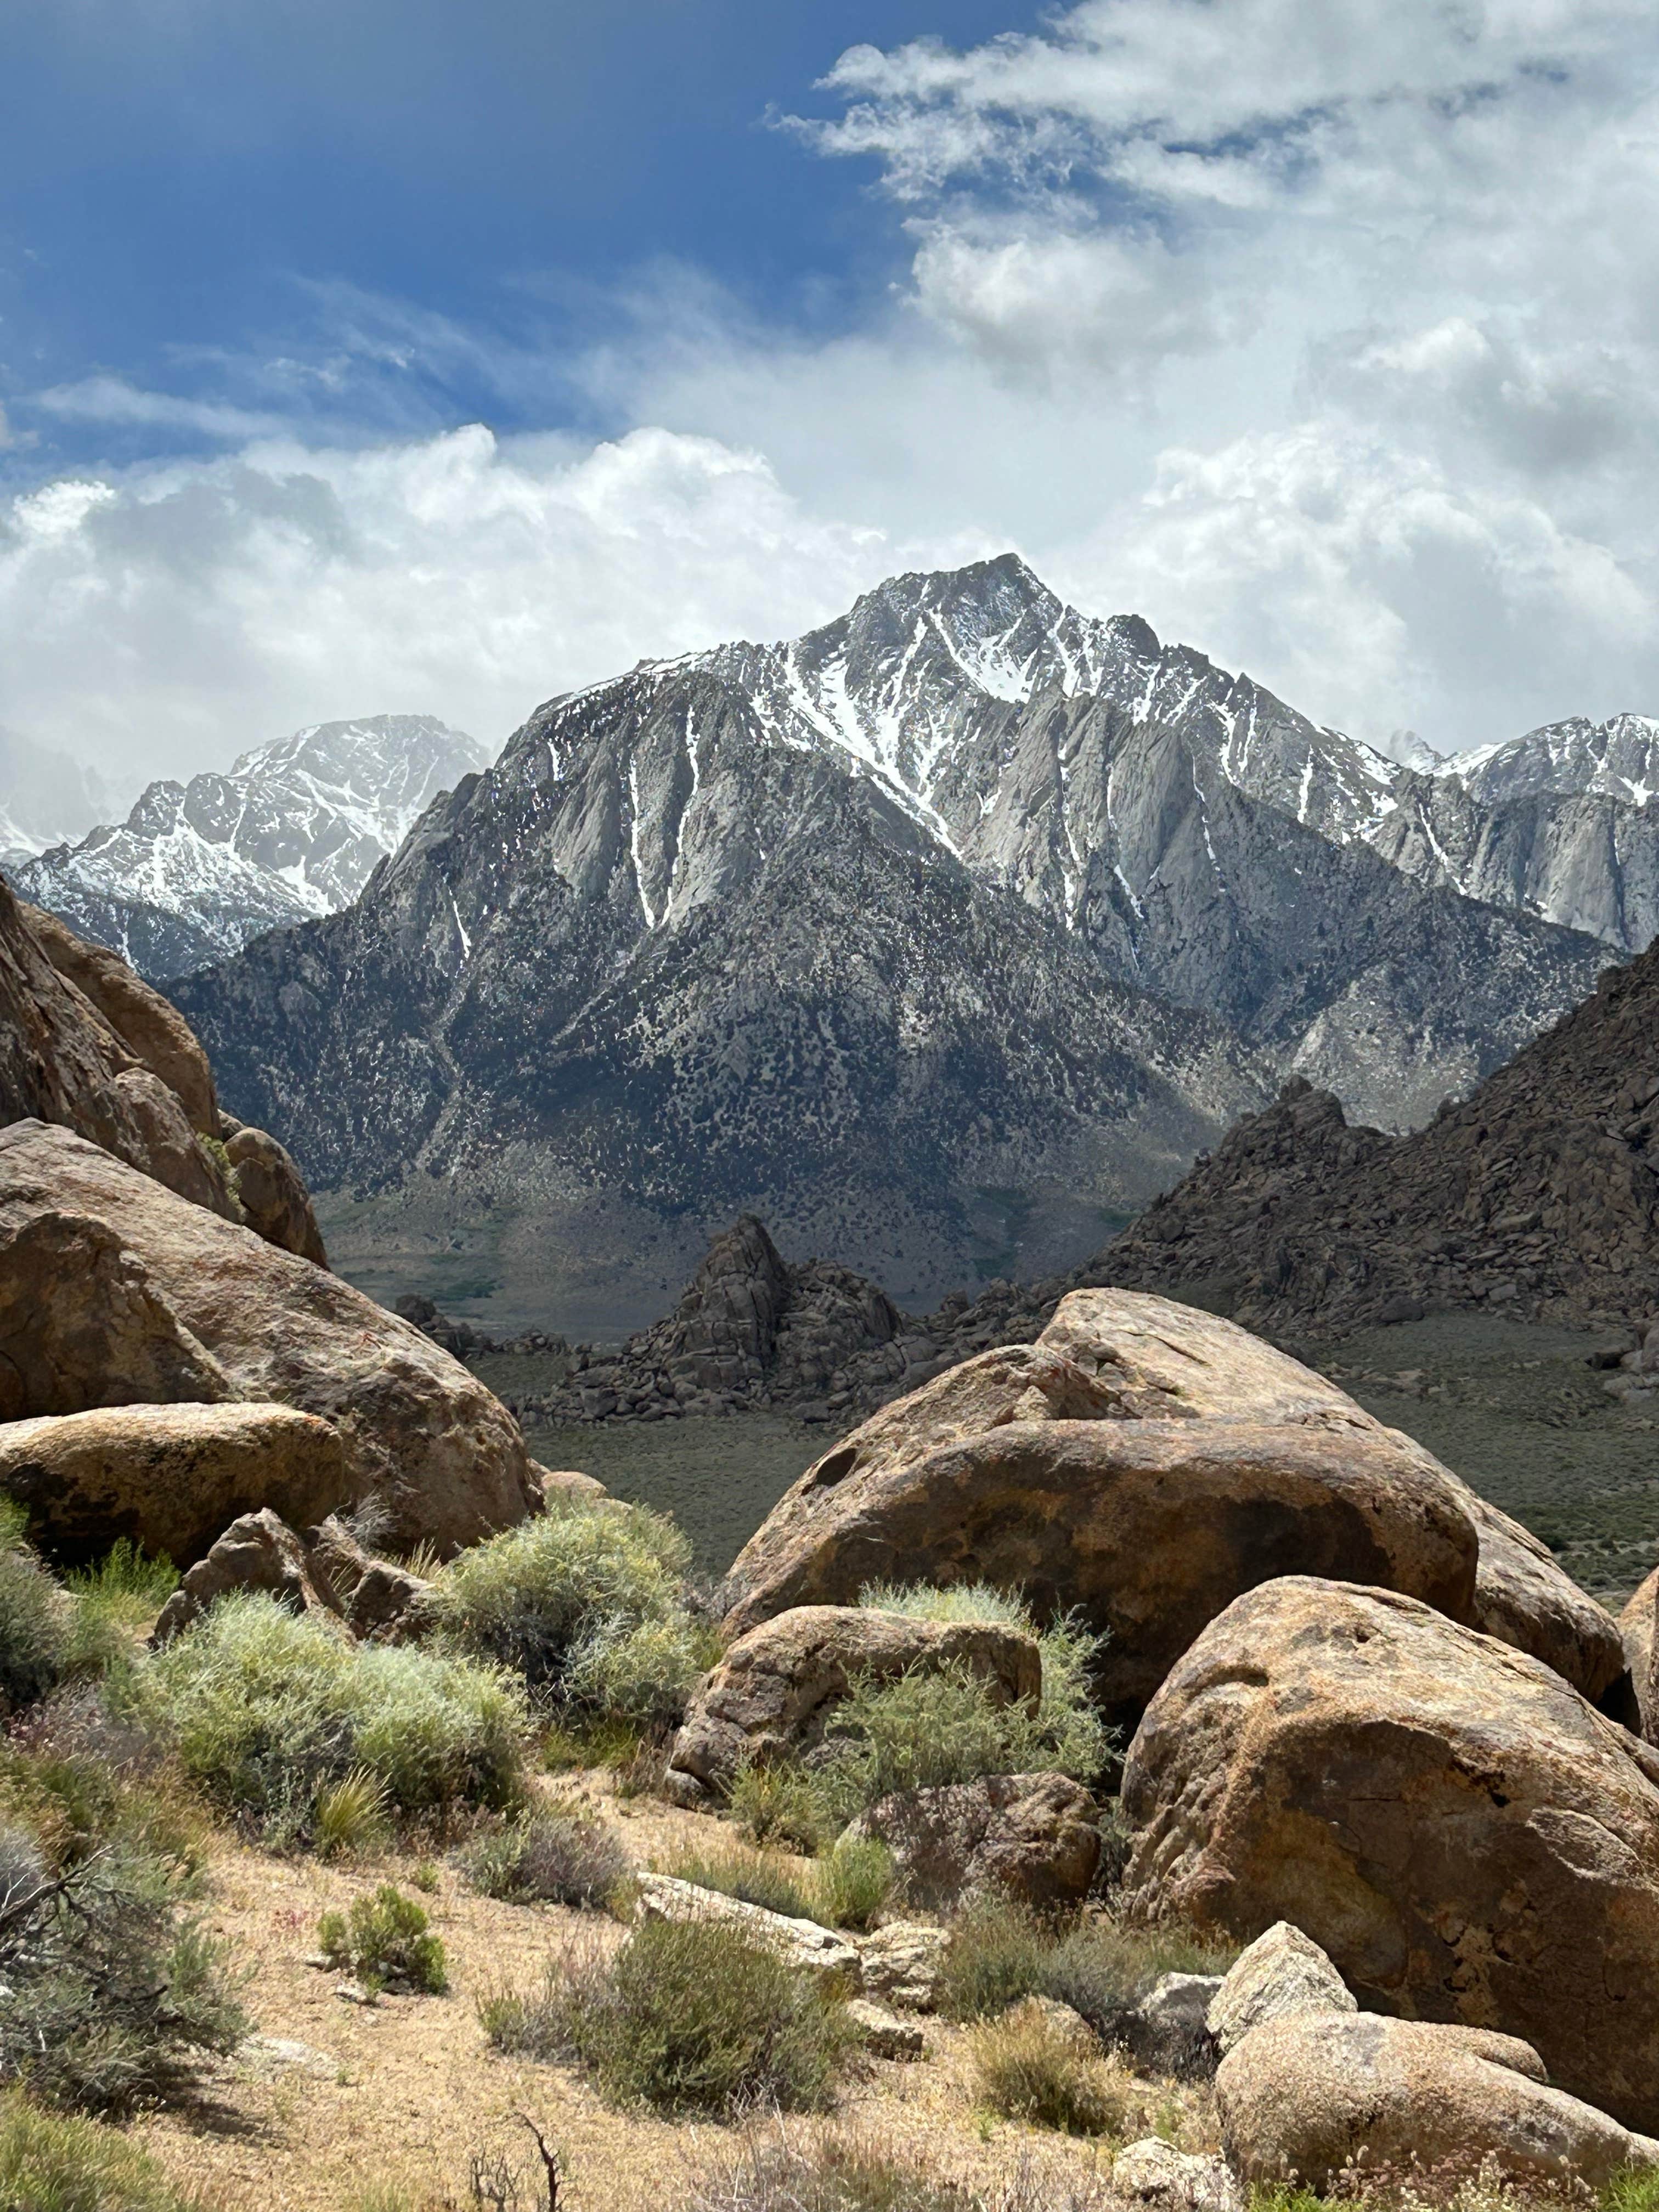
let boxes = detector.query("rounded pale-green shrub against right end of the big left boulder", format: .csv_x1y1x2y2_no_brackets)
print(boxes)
438,1500,714,1725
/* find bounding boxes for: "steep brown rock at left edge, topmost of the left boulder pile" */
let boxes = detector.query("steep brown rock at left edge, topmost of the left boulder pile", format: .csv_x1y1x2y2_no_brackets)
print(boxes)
0,883,234,1215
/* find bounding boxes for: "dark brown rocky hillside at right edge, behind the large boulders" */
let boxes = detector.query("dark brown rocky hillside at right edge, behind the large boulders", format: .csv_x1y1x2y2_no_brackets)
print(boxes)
1097,929,1659,1331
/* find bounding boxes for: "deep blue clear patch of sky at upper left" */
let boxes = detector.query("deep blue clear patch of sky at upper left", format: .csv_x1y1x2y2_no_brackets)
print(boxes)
0,0,1018,473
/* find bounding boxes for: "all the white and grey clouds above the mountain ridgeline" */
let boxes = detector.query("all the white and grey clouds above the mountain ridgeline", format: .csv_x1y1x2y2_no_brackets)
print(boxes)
0,0,1659,796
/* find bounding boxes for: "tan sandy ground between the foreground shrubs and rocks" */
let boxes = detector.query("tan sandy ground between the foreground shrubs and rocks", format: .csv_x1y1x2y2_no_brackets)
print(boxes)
133,1774,1210,2212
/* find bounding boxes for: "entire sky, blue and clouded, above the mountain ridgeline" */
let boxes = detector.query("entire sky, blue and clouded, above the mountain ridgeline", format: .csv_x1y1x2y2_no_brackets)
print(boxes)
0,0,1659,814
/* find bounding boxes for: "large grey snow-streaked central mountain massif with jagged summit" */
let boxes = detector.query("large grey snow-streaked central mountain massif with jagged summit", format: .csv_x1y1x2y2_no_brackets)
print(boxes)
162,555,1659,1334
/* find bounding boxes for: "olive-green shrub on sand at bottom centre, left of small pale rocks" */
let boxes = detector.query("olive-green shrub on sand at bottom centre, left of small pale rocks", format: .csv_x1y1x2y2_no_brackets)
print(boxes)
480,1920,851,2117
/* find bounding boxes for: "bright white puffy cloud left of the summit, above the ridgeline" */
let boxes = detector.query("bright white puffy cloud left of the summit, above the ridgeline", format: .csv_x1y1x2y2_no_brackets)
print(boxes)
0,425,960,783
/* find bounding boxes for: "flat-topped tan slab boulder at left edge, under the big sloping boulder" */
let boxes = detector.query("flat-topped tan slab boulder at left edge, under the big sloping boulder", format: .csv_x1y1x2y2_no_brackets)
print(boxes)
0,1400,349,1566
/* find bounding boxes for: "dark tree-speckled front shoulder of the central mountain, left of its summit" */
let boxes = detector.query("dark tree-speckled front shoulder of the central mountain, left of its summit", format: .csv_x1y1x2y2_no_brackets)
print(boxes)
175,668,1265,1316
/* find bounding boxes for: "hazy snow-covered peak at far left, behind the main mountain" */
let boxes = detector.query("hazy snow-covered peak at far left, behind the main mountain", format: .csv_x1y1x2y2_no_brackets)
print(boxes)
7,714,489,982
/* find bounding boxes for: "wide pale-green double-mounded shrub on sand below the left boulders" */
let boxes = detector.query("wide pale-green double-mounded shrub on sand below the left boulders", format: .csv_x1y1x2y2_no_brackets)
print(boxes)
148,1595,529,1841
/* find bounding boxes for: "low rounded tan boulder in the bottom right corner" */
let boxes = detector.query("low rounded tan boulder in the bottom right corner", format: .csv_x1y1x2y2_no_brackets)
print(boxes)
1217,2013,1659,2192
